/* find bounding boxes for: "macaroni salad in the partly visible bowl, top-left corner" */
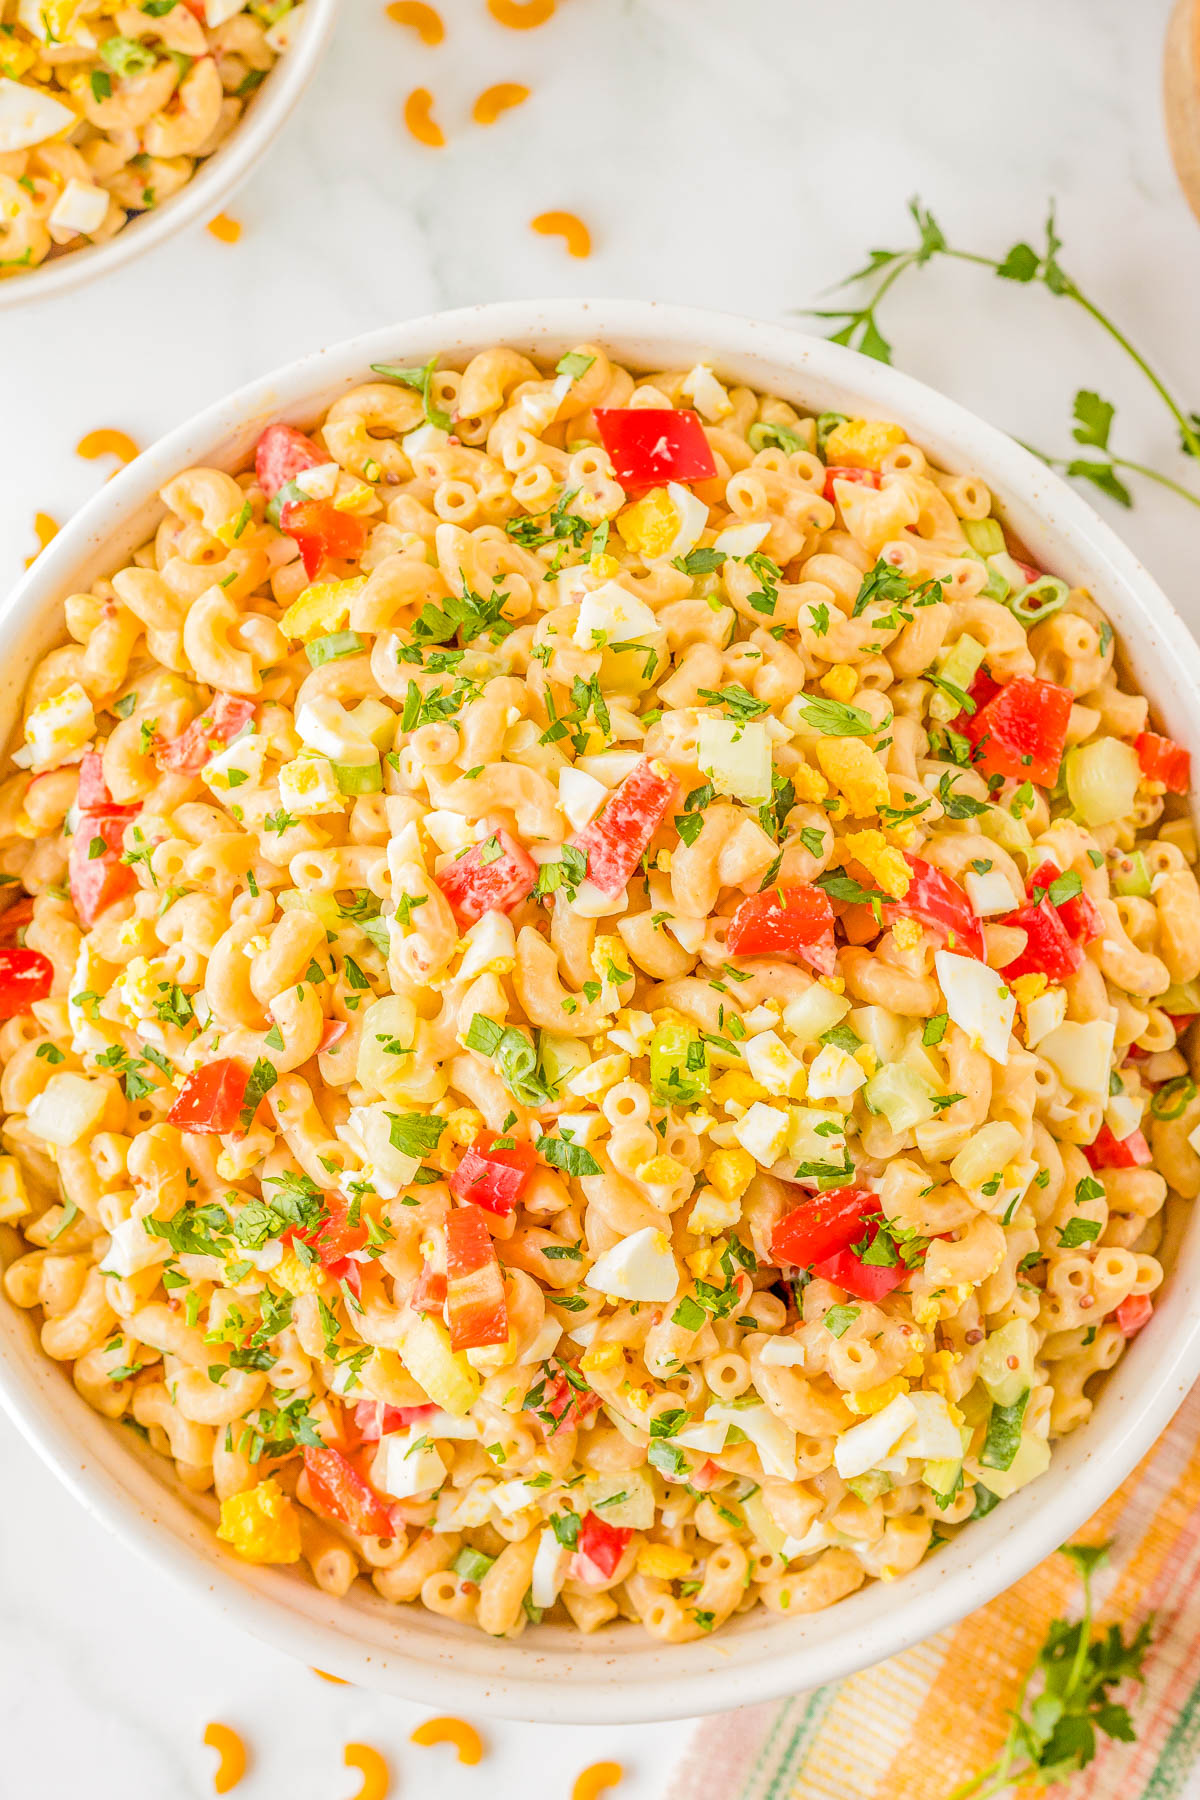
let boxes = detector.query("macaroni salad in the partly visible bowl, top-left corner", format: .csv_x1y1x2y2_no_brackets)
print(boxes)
0,0,300,279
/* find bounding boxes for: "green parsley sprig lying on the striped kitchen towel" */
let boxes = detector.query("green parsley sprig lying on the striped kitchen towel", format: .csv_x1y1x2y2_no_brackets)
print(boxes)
946,1544,1151,1800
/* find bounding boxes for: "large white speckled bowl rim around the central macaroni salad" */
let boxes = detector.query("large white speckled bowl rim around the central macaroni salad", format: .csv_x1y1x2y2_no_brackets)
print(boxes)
0,301,1200,1723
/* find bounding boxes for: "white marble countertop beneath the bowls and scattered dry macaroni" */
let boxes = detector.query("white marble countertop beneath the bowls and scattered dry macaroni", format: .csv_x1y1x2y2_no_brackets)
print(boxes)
0,0,1200,1800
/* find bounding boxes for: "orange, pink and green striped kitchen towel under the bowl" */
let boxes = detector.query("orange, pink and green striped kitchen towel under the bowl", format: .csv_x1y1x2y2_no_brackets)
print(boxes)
667,1388,1200,1800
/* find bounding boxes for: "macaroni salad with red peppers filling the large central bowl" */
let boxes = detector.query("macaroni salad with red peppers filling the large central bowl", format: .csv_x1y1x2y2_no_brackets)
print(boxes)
0,340,1200,1642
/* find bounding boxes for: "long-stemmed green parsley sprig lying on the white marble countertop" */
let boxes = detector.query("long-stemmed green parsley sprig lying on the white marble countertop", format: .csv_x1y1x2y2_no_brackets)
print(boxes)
811,200,1200,506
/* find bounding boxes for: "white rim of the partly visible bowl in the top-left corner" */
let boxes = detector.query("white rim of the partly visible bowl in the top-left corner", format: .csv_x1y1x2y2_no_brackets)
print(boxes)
0,0,342,311
